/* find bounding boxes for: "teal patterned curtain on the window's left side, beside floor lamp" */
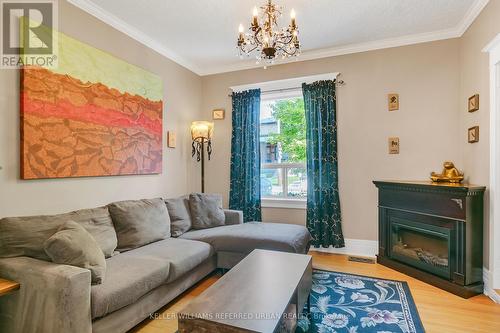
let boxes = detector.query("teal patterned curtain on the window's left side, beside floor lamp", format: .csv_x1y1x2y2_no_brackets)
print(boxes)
229,89,262,222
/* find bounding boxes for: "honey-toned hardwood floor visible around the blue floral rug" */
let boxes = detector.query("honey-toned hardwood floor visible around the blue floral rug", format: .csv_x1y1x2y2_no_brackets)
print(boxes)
130,251,500,333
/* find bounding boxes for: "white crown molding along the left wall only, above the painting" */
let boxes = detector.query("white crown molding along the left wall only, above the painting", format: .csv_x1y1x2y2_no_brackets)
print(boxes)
67,0,200,75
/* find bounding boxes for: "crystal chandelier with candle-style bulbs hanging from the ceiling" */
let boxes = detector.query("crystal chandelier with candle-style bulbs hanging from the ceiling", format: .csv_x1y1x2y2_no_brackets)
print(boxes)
237,0,300,64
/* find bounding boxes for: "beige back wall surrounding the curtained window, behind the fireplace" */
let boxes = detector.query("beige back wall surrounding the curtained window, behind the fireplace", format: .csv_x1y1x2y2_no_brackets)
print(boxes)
202,39,462,240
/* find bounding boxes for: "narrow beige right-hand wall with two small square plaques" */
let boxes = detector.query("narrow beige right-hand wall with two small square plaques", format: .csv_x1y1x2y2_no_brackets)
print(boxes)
459,0,500,267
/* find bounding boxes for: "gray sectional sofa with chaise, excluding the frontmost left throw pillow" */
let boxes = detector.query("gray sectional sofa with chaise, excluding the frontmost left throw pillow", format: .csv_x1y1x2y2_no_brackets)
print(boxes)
0,195,310,333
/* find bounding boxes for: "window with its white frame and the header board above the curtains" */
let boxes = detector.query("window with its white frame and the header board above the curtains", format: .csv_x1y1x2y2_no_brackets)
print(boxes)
230,72,339,209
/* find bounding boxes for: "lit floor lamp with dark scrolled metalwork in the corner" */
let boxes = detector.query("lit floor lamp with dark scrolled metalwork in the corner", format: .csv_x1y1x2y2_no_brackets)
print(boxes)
191,121,214,193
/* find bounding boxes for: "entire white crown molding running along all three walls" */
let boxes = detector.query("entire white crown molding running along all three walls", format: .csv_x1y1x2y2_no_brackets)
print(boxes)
68,0,489,76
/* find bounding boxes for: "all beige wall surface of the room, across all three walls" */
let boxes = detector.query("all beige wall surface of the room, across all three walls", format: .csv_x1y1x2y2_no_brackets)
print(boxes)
0,0,500,258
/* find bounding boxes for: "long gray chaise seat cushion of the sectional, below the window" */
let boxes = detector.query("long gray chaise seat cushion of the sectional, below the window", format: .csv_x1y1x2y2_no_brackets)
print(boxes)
181,222,311,254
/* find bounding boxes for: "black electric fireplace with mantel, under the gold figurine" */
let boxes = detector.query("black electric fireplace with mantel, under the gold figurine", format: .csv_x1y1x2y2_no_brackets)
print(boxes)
374,181,484,297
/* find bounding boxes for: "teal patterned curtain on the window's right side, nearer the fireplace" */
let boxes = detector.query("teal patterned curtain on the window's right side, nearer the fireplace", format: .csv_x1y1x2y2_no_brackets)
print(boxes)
302,80,345,247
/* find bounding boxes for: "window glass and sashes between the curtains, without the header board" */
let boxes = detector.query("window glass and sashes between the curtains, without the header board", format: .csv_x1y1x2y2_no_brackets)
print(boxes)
260,91,307,206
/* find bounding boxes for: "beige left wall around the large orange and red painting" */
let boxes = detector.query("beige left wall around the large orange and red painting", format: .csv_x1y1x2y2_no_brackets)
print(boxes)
0,1,201,217
